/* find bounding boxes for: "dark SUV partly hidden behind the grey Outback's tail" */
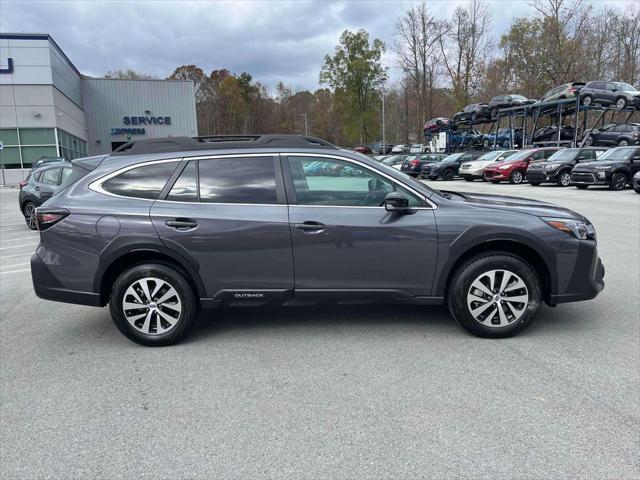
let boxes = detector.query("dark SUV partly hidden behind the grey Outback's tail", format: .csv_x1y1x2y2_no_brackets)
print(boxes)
18,161,72,230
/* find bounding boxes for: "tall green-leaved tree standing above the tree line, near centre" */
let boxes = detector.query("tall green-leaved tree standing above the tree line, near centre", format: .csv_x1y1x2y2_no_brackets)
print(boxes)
320,29,387,143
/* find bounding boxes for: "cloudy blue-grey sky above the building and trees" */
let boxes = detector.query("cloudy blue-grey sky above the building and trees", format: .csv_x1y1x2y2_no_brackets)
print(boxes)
0,0,640,89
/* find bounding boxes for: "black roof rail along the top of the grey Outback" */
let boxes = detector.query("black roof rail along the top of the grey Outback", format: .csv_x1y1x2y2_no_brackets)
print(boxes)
111,135,339,155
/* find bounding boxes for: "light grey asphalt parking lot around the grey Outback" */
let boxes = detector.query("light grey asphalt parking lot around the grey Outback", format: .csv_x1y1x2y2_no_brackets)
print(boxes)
0,181,640,479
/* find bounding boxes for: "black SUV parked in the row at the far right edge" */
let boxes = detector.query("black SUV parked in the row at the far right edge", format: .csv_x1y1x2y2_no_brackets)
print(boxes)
571,147,640,190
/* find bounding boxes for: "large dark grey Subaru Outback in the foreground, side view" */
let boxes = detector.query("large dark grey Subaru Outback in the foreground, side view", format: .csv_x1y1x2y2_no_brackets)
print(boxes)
31,135,604,345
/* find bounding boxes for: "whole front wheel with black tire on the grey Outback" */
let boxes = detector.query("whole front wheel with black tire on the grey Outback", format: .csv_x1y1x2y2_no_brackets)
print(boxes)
447,252,542,338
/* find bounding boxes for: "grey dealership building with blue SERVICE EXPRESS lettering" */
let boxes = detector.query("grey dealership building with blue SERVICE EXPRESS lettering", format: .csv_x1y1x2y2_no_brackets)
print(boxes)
0,33,198,169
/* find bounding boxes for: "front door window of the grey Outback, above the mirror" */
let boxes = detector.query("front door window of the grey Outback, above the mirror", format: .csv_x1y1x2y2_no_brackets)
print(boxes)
289,157,422,207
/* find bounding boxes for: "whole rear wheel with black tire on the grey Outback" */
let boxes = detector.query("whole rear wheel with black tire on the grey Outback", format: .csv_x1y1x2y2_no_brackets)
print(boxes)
109,263,198,347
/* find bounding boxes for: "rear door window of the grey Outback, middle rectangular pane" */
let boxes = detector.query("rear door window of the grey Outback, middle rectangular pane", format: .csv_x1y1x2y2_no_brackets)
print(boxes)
198,156,278,204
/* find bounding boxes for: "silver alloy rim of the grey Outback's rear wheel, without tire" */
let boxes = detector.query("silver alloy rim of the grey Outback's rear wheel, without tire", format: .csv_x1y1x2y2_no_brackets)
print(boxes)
122,277,182,335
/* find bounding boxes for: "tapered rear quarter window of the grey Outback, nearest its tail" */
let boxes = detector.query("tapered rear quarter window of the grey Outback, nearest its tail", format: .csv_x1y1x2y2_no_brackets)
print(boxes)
102,161,178,200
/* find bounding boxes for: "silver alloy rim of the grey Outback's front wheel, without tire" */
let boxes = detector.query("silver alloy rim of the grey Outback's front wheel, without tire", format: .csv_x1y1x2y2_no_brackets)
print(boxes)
467,270,529,328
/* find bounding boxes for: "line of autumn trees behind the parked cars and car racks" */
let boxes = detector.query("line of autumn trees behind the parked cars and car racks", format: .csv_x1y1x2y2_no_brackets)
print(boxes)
107,0,640,146
